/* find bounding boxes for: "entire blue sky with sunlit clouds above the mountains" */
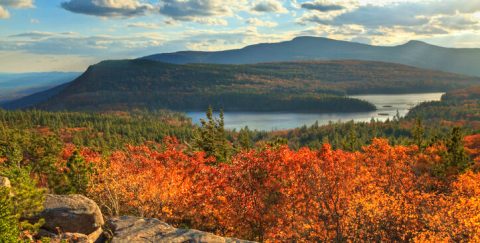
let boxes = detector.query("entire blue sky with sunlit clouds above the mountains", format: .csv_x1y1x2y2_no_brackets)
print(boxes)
0,0,480,73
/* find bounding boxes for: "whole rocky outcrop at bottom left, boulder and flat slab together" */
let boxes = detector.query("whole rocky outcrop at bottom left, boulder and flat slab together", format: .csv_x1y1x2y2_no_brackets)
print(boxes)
37,195,249,243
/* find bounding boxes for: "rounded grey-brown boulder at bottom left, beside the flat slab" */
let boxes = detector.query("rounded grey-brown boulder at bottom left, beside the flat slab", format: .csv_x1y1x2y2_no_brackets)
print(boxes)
38,194,104,235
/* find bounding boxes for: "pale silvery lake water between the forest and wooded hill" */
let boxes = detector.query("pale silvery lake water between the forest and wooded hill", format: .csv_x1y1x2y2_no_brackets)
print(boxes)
187,93,444,131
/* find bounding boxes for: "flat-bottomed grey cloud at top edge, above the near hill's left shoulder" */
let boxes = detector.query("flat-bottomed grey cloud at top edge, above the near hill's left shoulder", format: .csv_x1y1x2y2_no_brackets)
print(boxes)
61,0,154,17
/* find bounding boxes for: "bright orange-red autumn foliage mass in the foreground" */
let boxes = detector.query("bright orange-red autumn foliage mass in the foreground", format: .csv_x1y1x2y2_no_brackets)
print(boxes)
81,138,480,242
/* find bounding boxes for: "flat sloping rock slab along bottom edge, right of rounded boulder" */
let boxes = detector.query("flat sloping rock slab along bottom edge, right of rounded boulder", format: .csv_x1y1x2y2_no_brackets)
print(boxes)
107,216,253,243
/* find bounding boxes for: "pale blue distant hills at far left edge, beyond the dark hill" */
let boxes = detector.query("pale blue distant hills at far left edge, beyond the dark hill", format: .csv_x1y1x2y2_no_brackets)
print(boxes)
0,72,81,103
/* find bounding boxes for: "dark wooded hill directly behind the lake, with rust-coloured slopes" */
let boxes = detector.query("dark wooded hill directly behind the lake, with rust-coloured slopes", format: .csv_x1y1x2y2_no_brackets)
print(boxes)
4,59,480,112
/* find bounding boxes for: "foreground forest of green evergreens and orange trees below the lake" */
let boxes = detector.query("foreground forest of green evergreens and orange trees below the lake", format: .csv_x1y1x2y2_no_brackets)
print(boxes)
0,88,480,242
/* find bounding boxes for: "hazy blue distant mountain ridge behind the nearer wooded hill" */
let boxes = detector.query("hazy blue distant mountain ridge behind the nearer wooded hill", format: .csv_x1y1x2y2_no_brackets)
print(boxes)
142,37,480,76
